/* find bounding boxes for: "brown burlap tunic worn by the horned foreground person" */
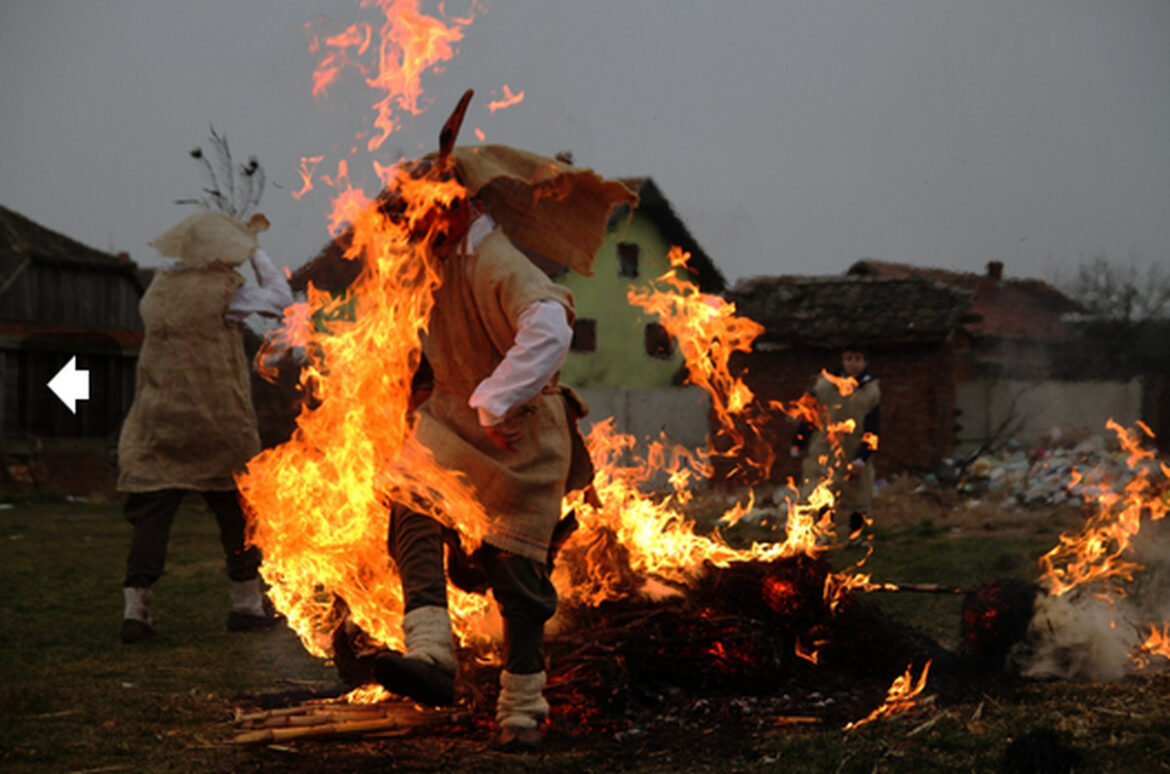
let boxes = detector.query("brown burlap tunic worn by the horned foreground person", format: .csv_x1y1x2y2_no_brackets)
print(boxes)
417,229,576,561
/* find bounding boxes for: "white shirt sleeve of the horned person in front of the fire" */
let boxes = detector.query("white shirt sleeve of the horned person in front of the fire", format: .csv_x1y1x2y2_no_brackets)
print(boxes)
467,300,573,426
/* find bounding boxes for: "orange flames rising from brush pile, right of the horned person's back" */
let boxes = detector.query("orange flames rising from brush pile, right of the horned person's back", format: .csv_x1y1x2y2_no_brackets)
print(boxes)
553,248,855,604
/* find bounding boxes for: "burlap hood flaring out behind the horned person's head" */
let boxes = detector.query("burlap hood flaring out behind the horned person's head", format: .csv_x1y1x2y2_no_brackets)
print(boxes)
452,145,638,277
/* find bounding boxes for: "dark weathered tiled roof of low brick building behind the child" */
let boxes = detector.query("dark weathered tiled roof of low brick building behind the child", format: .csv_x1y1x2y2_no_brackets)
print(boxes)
727,276,971,348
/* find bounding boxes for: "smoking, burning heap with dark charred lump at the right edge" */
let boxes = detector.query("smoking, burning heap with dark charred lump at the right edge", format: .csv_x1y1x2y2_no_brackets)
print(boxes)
963,422,1170,680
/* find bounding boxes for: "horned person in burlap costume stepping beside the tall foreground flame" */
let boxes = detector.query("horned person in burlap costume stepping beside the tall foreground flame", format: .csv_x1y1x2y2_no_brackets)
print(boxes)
374,146,636,751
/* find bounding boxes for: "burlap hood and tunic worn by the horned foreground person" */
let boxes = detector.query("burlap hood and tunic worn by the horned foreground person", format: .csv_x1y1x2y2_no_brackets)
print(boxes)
417,146,636,562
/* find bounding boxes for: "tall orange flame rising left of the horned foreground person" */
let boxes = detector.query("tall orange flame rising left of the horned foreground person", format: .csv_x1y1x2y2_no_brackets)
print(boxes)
238,0,488,668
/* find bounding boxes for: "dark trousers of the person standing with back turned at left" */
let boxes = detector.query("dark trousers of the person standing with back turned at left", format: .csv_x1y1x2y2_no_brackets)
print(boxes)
123,489,260,587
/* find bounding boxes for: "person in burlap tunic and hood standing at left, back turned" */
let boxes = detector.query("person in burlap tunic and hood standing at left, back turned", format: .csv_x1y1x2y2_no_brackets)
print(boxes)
118,212,293,643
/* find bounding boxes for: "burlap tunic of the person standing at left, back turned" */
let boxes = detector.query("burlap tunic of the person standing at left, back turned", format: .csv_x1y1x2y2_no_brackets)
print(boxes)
118,264,260,492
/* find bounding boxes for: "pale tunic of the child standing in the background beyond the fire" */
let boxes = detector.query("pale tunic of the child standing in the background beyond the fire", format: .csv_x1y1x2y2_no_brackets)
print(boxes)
801,374,881,513
